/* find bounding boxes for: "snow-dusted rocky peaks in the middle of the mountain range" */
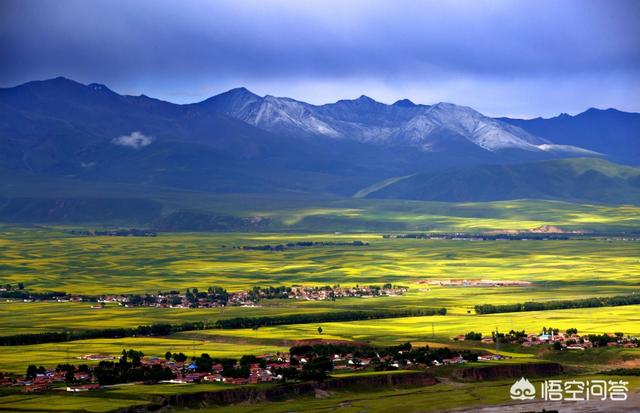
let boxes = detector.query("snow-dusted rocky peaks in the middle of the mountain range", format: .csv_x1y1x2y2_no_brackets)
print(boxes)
197,88,598,155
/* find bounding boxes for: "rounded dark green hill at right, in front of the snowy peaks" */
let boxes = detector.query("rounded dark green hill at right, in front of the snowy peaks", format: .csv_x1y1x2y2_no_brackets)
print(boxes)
359,158,640,204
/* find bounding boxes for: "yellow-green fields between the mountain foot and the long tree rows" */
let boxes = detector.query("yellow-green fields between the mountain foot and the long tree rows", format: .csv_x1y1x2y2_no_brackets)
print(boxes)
0,228,640,335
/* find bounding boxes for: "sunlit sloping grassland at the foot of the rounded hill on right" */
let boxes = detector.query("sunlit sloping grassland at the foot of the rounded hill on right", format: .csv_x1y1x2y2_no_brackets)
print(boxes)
246,195,640,232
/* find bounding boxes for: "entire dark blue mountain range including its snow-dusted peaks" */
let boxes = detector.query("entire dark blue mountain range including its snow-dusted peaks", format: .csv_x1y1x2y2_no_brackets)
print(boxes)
0,77,640,212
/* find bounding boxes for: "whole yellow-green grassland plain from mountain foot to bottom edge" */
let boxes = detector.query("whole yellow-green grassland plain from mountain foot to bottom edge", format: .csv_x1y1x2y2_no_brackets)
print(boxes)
0,200,640,412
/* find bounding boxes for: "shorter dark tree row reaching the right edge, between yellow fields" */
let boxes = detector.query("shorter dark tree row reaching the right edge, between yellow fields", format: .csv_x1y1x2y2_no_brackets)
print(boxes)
475,293,640,314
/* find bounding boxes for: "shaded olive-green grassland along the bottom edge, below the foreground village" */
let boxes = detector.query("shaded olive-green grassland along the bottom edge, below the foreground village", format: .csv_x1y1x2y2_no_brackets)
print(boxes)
0,375,640,413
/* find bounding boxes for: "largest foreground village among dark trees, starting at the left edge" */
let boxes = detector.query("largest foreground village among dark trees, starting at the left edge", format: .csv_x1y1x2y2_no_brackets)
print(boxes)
0,340,480,393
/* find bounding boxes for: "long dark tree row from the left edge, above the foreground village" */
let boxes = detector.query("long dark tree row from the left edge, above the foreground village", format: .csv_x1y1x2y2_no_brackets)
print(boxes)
0,308,447,346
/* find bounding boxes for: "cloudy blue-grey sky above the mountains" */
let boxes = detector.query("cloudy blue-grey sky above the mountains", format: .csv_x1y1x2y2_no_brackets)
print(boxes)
0,0,640,117
